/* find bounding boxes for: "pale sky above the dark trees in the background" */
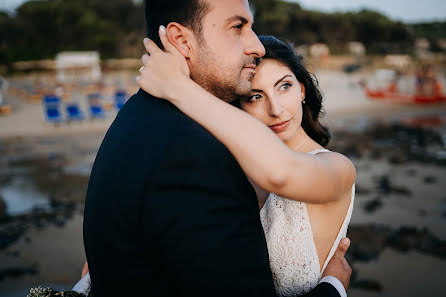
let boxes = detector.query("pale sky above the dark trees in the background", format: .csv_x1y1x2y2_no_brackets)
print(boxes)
0,0,446,23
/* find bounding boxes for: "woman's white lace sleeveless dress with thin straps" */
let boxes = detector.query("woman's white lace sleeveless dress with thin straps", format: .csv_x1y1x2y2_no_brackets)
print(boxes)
260,149,355,296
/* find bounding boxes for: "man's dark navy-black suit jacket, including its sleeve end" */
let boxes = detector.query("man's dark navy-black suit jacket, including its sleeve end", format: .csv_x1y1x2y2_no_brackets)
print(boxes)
84,90,339,297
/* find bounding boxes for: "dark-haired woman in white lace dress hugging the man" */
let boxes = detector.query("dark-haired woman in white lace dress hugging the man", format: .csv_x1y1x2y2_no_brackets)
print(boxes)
137,29,356,296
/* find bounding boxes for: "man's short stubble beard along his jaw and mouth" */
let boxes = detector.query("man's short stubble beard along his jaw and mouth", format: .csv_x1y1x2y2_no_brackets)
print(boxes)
190,40,255,102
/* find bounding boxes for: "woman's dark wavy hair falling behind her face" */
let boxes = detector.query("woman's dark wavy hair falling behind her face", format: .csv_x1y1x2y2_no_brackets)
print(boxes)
237,36,331,146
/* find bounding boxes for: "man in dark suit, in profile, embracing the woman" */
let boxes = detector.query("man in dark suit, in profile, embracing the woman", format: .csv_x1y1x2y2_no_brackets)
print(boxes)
84,0,351,297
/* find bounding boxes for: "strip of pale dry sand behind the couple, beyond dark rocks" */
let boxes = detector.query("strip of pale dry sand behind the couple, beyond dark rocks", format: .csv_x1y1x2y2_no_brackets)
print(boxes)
0,70,446,138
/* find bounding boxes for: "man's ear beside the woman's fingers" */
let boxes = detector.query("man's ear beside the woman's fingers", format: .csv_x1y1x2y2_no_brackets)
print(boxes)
166,22,195,59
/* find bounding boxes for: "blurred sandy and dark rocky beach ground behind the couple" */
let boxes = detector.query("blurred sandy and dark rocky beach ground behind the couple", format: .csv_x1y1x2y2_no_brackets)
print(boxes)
0,71,446,297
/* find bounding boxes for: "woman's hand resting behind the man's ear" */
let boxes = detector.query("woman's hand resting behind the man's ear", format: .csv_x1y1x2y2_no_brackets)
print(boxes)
136,26,192,101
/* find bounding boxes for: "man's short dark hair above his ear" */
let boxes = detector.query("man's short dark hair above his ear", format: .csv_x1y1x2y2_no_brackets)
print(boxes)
144,0,209,48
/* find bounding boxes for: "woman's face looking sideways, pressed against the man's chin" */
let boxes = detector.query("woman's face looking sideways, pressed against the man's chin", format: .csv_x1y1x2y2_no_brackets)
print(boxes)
240,59,305,142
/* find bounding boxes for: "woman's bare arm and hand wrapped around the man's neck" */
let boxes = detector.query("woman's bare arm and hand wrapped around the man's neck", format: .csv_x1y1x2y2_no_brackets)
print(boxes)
137,27,356,203
